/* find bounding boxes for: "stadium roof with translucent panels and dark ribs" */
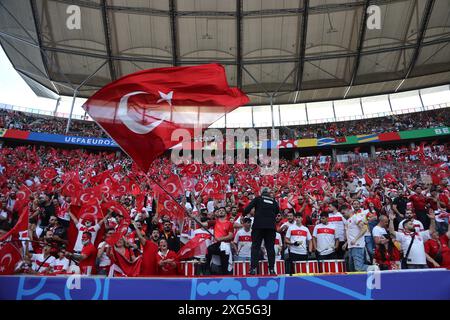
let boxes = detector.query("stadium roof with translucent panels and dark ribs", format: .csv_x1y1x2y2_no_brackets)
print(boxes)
0,0,450,105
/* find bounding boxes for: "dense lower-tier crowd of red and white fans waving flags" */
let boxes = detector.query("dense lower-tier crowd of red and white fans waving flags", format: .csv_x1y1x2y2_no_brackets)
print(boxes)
0,140,450,276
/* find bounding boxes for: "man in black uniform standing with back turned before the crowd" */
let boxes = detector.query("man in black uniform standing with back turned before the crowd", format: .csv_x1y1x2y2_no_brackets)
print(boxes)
244,187,280,275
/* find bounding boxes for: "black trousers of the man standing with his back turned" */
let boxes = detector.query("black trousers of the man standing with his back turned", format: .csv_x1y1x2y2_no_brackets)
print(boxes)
251,229,276,270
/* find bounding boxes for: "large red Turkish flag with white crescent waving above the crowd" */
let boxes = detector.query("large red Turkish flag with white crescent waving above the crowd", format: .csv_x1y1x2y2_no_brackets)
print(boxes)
83,64,249,172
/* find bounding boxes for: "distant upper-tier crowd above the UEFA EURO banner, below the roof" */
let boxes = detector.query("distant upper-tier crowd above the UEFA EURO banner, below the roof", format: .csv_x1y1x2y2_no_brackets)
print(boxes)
0,108,450,140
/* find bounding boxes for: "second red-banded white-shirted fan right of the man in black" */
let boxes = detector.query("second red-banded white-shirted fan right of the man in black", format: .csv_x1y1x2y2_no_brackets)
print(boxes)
313,212,339,260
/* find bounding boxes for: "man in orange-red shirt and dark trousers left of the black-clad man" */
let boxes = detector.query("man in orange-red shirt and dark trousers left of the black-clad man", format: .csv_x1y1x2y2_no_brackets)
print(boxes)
205,208,234,274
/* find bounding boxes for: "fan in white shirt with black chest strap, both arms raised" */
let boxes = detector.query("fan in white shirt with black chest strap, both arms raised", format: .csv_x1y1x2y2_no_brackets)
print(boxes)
389,209,436,269
